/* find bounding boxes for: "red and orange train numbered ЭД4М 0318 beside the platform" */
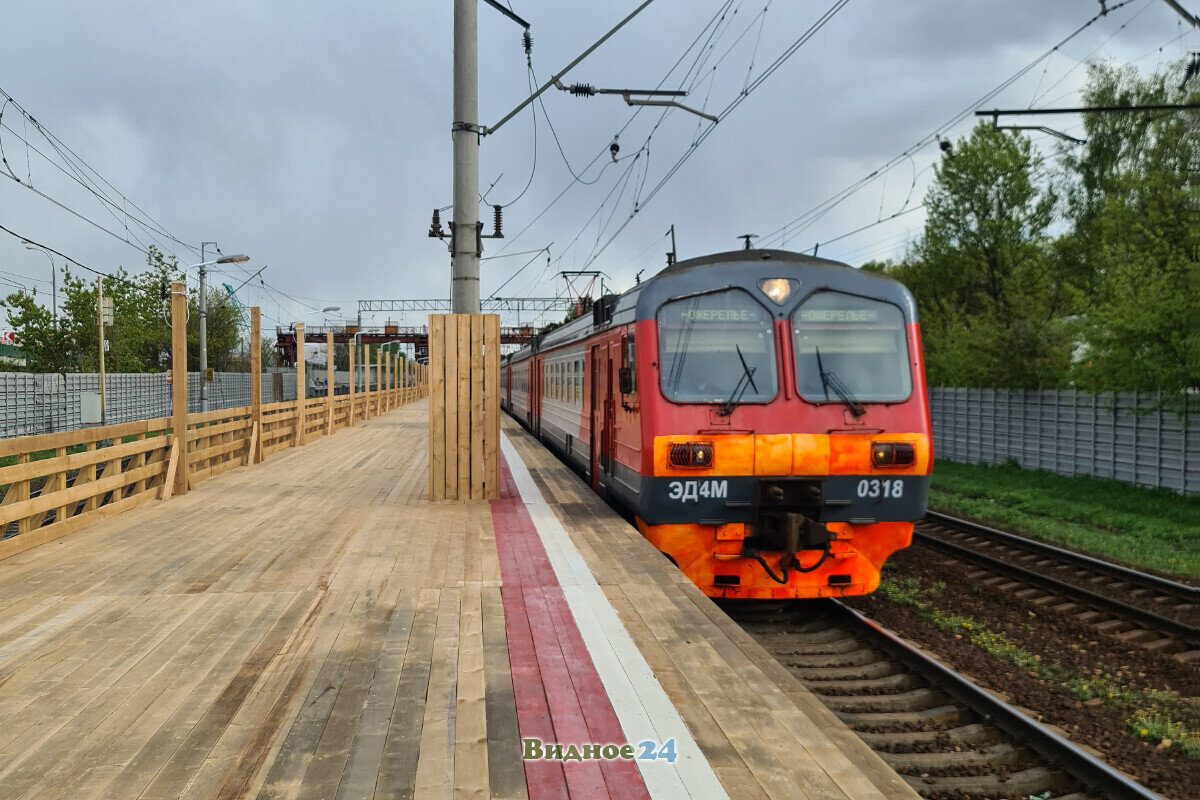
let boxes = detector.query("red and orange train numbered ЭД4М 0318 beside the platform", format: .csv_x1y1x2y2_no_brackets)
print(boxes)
502,249,932,599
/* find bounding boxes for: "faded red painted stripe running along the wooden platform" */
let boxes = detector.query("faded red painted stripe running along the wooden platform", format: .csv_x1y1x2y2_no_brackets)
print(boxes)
492,459,649,800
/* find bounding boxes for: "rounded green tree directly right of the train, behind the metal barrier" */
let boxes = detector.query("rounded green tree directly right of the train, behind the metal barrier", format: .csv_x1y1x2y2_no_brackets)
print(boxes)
902,124,1069,386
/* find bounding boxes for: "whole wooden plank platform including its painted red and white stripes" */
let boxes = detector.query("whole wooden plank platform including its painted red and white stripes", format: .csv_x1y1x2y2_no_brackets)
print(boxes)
0,404,916,800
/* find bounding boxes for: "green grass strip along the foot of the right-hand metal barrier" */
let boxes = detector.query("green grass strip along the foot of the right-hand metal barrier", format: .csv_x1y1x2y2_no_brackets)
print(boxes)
929,462,1200,578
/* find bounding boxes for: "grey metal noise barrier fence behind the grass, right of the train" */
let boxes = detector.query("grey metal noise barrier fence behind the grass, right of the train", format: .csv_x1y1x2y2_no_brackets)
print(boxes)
929,389,1200,494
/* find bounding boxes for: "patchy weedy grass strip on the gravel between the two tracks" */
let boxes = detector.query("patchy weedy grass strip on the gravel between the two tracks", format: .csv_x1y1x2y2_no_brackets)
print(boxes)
880,570,1200,760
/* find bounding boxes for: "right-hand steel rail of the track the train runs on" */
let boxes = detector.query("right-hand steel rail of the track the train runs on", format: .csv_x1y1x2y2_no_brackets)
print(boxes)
828,600,1163,800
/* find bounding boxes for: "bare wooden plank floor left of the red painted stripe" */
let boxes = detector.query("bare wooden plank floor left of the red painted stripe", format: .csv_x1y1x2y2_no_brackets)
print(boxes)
0,404,516,800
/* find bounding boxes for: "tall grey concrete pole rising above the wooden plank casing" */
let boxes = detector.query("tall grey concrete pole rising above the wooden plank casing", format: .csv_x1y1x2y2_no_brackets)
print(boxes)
450,0,479,314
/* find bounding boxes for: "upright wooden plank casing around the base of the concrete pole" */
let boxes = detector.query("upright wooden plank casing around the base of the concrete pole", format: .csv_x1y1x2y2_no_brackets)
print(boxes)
428,314,500,500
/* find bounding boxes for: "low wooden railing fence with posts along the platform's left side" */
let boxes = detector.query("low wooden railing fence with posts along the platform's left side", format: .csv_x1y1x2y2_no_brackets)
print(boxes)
0,302,428,559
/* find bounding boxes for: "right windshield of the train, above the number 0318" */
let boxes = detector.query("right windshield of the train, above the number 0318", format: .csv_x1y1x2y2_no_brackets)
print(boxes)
792,291,912,408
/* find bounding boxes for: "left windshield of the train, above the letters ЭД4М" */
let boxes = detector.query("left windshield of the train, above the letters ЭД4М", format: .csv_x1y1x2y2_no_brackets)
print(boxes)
658,289,778,404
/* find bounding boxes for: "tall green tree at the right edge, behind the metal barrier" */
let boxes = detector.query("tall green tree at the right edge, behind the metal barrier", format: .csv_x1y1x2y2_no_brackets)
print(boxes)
1057,62,1200,391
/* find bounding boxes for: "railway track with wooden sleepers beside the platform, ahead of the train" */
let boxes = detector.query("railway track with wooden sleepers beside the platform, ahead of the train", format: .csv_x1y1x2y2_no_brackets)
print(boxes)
724,601,1160,800
